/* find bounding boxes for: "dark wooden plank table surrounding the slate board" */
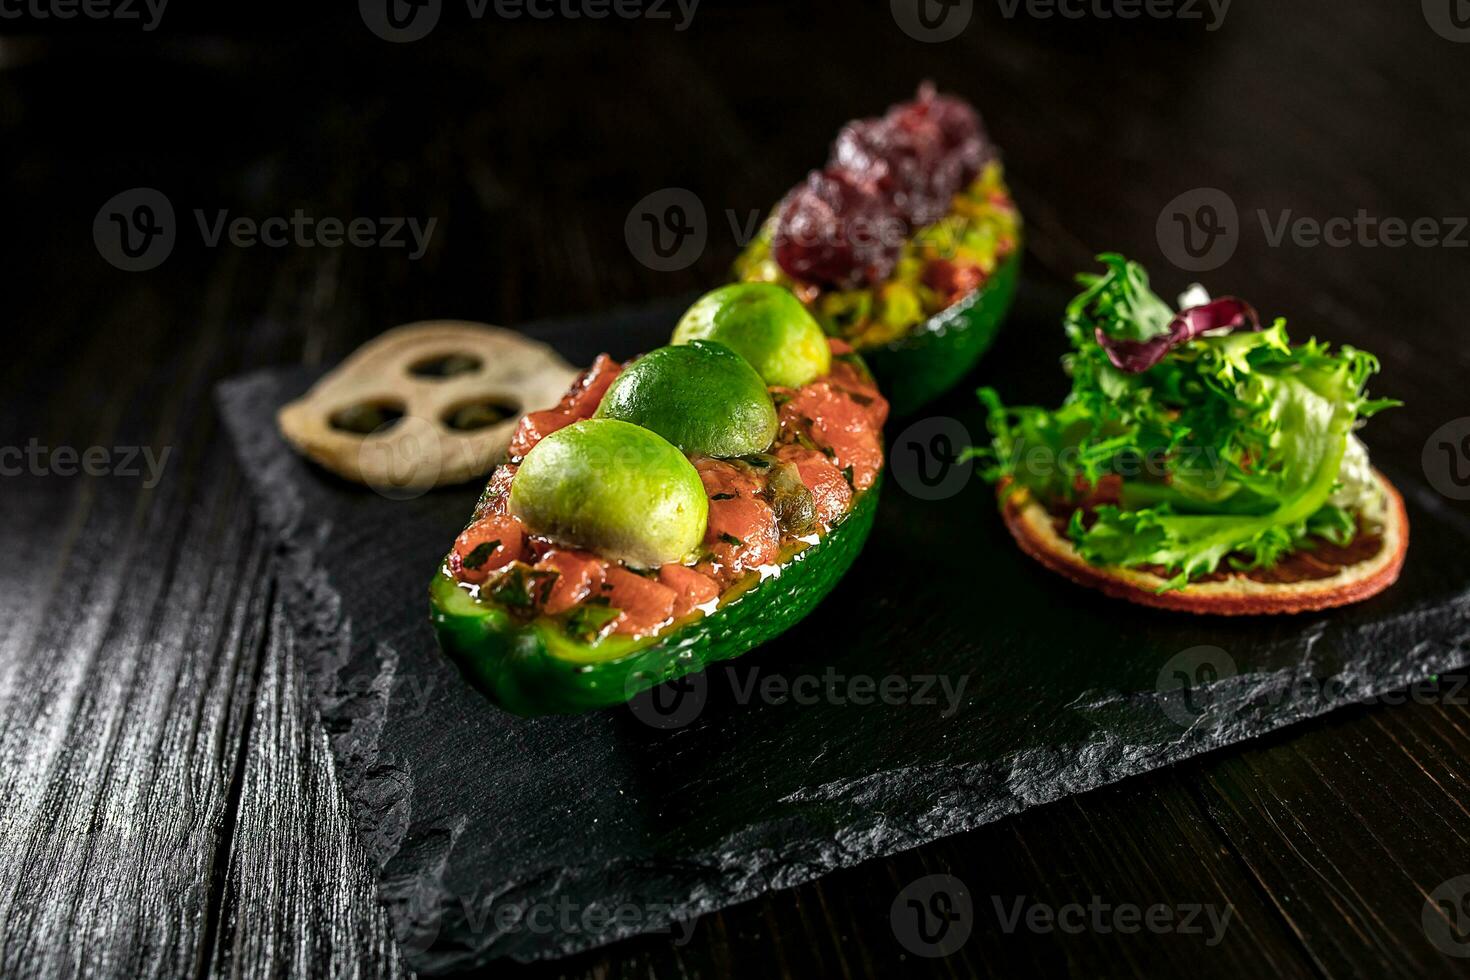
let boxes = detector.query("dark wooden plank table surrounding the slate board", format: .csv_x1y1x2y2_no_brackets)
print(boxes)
0,0,1470,977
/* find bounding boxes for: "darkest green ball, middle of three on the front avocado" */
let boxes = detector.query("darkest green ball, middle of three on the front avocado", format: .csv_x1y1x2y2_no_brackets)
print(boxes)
597,341,778,455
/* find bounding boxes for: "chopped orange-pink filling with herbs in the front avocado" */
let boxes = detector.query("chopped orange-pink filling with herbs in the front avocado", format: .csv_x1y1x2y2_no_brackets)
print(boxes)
447,339,888,636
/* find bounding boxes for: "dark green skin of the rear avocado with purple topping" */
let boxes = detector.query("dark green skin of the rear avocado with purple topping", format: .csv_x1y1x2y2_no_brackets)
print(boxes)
860,242,1022,417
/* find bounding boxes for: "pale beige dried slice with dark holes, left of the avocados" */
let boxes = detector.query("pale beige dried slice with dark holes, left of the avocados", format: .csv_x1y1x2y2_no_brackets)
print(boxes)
276,320,578,497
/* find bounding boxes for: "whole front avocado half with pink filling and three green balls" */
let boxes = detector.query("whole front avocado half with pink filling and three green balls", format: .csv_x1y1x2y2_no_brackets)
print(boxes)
429,283,888,714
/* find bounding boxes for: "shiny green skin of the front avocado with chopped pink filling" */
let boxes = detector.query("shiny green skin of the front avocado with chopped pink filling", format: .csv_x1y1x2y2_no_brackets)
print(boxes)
429,478,879,716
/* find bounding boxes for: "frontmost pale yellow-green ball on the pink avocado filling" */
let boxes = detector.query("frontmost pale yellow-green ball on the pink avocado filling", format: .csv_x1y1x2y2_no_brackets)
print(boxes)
510,419,710,569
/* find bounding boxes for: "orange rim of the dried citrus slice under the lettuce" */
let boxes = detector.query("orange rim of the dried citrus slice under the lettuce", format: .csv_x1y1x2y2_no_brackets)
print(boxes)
1001,470,1408,616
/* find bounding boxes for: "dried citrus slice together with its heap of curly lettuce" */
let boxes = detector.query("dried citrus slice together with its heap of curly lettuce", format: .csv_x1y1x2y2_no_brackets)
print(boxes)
972,254,1408,614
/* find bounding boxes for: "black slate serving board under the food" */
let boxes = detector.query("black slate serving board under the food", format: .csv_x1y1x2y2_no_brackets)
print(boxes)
219,276,1470,973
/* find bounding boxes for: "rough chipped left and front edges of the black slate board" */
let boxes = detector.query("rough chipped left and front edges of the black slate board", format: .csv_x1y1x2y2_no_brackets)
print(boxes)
218,370,1470,974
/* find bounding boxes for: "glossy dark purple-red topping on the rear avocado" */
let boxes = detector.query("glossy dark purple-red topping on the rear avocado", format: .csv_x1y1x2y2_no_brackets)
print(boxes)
772,84,991,287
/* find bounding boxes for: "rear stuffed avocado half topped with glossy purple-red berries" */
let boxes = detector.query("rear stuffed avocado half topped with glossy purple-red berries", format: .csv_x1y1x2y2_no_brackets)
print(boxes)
735,87,1022,416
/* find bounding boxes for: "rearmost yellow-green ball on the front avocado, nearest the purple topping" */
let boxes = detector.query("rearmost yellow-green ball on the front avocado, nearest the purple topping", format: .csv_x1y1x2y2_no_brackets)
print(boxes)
673,282,832,388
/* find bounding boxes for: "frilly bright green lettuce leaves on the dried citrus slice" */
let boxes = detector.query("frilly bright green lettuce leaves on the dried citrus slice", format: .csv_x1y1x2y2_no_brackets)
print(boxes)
970,254,1398,589
